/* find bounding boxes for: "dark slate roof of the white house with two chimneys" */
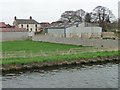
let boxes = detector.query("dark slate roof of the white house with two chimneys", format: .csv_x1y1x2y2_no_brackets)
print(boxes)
15,19,39,24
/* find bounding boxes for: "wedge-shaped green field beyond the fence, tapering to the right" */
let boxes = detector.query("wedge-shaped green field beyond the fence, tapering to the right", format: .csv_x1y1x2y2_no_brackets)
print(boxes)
2,40,83,53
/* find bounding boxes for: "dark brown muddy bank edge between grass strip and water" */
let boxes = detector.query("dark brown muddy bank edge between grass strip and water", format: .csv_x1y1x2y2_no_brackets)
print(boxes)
2,56,120,73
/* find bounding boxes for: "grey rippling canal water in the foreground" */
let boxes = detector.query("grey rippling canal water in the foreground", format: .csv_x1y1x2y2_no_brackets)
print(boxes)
2,63,118,88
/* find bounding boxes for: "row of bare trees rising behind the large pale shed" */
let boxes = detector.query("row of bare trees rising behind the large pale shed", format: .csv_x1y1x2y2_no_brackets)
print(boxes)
59,6,120,32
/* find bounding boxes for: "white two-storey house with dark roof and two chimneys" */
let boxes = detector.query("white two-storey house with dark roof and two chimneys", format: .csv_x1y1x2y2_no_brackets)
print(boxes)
13,16,40,32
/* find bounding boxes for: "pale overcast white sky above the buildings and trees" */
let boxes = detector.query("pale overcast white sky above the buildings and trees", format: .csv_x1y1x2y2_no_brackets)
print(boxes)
0,0,120,25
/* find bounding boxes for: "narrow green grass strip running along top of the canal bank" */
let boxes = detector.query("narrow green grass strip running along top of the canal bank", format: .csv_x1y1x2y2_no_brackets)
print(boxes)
2,51,120,65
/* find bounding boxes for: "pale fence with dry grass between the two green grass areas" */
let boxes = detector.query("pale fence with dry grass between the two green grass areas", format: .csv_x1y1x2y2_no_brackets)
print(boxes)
1,47,116,58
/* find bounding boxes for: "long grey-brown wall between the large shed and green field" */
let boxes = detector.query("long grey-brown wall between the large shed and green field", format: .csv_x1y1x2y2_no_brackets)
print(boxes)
32,35,118,49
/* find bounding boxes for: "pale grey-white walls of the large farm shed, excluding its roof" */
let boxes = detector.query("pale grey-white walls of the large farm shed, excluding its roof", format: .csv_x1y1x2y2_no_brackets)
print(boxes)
48,23,102,38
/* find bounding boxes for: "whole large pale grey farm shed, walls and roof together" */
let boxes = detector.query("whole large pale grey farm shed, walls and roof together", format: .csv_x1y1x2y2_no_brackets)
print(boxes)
47,22,102,38
